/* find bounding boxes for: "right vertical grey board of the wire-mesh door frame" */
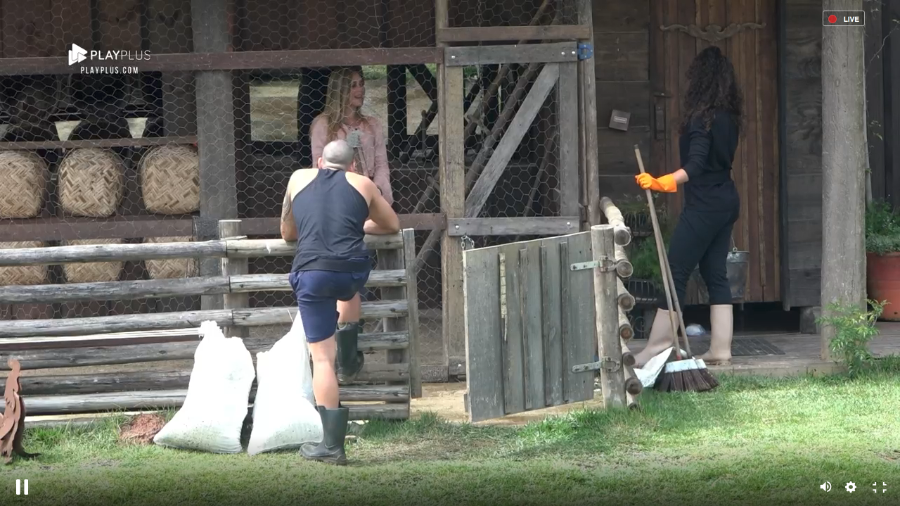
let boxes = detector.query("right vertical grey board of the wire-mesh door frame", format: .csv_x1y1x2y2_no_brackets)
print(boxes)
556,62,581,216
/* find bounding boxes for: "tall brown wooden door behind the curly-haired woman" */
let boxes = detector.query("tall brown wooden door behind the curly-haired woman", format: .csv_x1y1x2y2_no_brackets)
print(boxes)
650,0,781,303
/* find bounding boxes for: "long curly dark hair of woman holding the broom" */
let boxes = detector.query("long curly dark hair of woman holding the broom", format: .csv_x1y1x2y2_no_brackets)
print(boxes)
680,46,744,133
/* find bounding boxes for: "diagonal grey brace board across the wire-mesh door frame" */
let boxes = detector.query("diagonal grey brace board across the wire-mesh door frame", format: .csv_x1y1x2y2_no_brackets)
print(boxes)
468,63,559,215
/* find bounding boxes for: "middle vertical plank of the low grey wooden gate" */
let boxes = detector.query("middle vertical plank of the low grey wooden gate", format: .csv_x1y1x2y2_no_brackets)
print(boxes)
519,241,546,410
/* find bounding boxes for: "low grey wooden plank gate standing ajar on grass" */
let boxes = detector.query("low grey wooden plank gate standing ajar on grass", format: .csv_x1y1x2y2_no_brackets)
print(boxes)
463,232,597,422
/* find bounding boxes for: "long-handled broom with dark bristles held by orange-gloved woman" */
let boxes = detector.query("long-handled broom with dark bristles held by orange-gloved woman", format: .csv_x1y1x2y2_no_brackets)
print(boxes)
634,144,719,392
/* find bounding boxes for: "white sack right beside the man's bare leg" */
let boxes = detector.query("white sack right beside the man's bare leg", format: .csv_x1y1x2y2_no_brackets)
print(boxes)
247,313,323,455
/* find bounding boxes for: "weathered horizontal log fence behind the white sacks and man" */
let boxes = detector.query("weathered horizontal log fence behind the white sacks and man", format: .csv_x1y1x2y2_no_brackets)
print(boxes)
0,220,422,420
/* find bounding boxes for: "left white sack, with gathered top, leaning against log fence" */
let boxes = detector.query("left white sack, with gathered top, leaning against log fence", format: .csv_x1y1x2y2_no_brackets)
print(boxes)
153,321,255,453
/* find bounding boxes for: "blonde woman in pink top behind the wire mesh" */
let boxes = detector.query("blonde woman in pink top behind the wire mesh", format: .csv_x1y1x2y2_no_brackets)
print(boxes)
309,67,394,204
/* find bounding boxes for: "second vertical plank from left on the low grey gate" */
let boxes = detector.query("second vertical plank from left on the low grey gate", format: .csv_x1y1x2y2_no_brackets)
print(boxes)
498,244,525,415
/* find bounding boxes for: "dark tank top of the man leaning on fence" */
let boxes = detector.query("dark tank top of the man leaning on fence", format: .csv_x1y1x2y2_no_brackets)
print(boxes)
291,169,371,272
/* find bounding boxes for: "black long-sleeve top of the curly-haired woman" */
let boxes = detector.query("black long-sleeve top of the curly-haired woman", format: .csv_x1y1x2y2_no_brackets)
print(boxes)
678,111,740,212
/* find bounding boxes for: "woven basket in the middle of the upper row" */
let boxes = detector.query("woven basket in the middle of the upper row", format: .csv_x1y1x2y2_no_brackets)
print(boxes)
59,148,125,218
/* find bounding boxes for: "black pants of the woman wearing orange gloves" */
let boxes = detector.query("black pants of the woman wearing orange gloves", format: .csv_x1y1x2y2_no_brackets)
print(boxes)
659,208,739,309
